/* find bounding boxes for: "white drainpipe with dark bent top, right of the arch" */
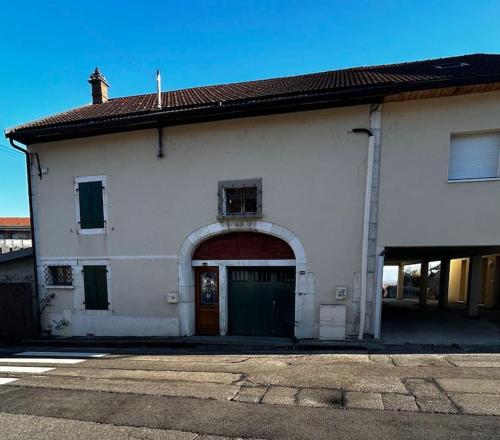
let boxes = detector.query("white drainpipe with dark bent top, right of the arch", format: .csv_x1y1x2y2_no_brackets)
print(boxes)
352,128,375,339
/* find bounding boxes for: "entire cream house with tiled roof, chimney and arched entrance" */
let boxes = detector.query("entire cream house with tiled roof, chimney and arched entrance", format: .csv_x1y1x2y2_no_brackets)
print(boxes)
6,55,500,339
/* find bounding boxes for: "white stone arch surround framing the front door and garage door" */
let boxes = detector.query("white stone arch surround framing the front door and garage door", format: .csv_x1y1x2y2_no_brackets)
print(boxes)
178,220,315,339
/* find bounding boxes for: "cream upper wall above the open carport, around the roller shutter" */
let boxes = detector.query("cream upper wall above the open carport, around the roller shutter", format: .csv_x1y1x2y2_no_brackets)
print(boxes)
378,92,500,246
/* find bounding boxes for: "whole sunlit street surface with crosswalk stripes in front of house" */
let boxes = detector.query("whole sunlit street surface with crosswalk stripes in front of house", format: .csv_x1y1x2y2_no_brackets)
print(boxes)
0,348,500,440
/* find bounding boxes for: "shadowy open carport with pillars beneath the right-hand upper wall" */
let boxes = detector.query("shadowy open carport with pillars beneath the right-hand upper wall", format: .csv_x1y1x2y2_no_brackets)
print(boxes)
381,246,500,345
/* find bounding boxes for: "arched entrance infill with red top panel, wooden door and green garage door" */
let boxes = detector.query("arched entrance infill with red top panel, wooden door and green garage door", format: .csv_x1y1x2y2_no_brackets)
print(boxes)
193,232,295,337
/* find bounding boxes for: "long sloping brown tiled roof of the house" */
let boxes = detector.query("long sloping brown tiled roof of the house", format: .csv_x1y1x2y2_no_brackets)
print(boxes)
6,54,500,140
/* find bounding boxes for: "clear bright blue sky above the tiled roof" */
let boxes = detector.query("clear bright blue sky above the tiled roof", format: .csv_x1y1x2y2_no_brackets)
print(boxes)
0,0,500,216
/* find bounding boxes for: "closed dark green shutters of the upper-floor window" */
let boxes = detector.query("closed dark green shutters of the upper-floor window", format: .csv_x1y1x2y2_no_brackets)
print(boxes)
78,180,104,229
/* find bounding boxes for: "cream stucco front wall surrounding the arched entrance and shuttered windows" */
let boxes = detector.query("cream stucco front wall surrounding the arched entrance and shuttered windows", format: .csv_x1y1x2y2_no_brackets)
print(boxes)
32,106,370,337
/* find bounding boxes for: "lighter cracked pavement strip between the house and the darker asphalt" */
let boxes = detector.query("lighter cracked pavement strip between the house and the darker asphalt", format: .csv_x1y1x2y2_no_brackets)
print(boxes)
0,349,500,415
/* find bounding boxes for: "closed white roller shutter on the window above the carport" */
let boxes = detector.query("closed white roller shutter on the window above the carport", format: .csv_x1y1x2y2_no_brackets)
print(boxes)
448,132,500,180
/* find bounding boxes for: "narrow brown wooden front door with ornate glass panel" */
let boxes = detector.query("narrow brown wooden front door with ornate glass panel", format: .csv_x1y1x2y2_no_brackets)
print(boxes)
195,267,219,335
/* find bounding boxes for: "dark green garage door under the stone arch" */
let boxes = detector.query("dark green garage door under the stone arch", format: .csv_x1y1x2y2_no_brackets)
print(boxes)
228,267,295,337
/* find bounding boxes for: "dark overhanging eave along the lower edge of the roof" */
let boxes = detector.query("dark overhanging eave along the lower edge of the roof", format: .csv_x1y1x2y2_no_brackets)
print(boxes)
5,73,500,145
